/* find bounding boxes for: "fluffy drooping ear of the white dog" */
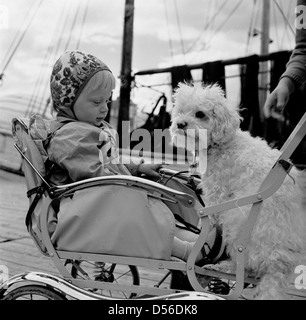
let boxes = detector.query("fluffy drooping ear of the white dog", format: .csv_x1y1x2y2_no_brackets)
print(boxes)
209,85,241,145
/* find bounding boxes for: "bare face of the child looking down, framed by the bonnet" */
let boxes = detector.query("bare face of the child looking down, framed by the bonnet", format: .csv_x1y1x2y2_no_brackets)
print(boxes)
74,88,112,127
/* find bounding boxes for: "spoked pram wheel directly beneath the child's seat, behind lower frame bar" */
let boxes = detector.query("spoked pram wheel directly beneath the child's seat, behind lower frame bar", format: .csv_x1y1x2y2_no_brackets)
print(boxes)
71,261,140,299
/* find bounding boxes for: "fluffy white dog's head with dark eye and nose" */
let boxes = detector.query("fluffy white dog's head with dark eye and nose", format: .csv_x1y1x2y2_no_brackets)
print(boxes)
170,83,241,152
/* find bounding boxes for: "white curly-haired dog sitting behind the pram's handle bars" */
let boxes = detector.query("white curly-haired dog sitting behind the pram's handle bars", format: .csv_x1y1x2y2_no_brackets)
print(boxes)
170,83,306,299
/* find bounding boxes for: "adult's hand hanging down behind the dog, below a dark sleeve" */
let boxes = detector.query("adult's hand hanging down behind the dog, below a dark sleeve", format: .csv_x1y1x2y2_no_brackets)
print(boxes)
263,77,295,119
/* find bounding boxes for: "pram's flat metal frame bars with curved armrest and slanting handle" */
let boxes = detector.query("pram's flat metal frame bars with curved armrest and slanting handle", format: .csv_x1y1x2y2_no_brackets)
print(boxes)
8,114,306,299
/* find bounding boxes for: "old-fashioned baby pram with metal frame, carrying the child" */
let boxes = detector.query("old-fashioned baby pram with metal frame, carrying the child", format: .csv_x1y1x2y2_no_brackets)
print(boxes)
1,115,306,299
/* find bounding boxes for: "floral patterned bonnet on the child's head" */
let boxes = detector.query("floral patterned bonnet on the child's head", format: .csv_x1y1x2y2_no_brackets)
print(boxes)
50,51,111,108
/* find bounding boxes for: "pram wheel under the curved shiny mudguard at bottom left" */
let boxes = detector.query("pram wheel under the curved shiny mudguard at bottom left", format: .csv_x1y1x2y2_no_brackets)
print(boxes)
2,285,66,300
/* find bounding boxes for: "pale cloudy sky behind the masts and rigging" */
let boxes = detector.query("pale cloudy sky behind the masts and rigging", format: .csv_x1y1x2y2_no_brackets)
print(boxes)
0,0,296,123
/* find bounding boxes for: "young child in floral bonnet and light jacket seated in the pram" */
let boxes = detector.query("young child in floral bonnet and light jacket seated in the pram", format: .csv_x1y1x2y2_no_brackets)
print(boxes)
47,51,220,261
